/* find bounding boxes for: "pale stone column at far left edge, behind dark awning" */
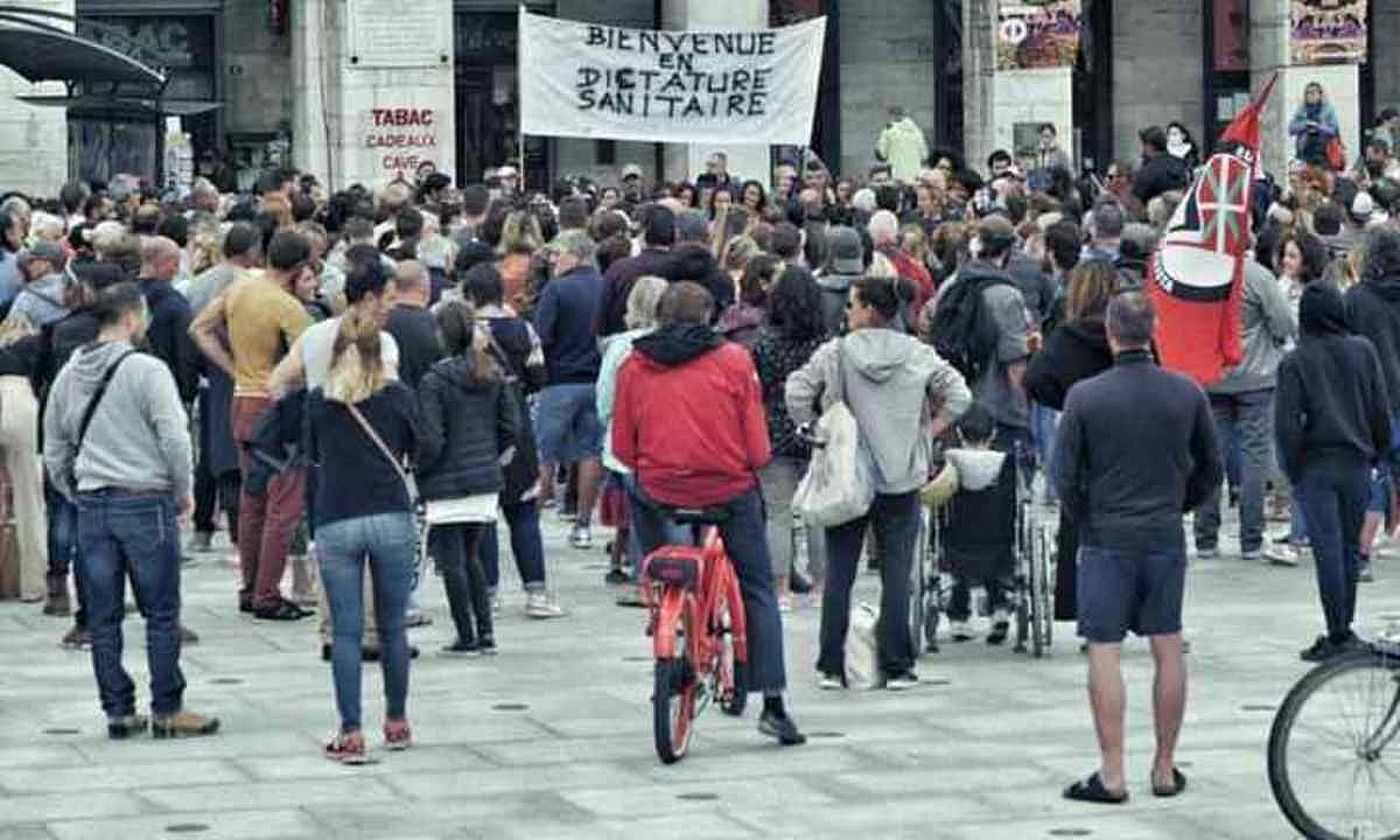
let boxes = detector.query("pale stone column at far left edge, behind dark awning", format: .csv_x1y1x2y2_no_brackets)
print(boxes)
0,0,73,196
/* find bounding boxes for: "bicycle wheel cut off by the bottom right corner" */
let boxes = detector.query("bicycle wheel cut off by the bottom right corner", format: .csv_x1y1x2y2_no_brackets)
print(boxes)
1268,652,1400,840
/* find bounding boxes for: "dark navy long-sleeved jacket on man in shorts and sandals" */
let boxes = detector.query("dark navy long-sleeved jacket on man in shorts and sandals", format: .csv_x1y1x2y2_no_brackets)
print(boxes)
1051,350,1224,552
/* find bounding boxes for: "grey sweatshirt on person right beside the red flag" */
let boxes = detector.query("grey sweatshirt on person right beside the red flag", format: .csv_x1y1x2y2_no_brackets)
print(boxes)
1205,259,1298,393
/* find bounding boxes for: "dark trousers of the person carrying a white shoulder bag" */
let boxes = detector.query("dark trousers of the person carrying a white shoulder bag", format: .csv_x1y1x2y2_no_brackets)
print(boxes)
816,493,918,676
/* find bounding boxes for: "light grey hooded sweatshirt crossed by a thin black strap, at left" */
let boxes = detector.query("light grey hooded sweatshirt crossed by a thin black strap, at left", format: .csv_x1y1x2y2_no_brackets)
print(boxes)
43,342,192,498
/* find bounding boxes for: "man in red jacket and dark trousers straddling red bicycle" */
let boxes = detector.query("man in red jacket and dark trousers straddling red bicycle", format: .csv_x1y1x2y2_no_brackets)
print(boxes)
612,283,806,746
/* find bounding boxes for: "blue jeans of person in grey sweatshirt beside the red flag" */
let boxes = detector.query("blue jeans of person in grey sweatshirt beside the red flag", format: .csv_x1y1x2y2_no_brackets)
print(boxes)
1196,388,1274,552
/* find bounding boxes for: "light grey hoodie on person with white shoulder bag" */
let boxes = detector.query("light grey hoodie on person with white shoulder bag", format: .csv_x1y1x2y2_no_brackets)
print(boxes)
785,329,972,494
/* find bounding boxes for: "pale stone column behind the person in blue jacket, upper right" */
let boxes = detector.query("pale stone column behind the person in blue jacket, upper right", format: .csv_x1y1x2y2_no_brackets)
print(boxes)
1249,0,1360,182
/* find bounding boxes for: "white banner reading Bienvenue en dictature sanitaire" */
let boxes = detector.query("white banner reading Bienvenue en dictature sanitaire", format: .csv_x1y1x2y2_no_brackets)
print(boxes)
519,8,826,146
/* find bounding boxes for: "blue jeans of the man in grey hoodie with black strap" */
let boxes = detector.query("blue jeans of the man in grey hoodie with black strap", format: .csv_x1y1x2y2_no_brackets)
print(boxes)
77,490,185,718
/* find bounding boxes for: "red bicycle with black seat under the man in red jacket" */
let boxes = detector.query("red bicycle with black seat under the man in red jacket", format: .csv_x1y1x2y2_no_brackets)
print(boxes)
643,508,749,764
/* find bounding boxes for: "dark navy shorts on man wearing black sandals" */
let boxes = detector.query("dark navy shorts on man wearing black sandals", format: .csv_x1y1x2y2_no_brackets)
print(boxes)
1078,546,1186,644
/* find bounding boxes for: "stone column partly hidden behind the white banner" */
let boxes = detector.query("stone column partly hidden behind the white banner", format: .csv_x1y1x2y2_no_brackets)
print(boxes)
661,0,769,183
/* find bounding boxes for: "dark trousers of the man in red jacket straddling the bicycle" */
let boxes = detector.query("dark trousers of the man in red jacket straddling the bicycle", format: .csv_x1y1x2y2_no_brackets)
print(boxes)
627,484,787,693
